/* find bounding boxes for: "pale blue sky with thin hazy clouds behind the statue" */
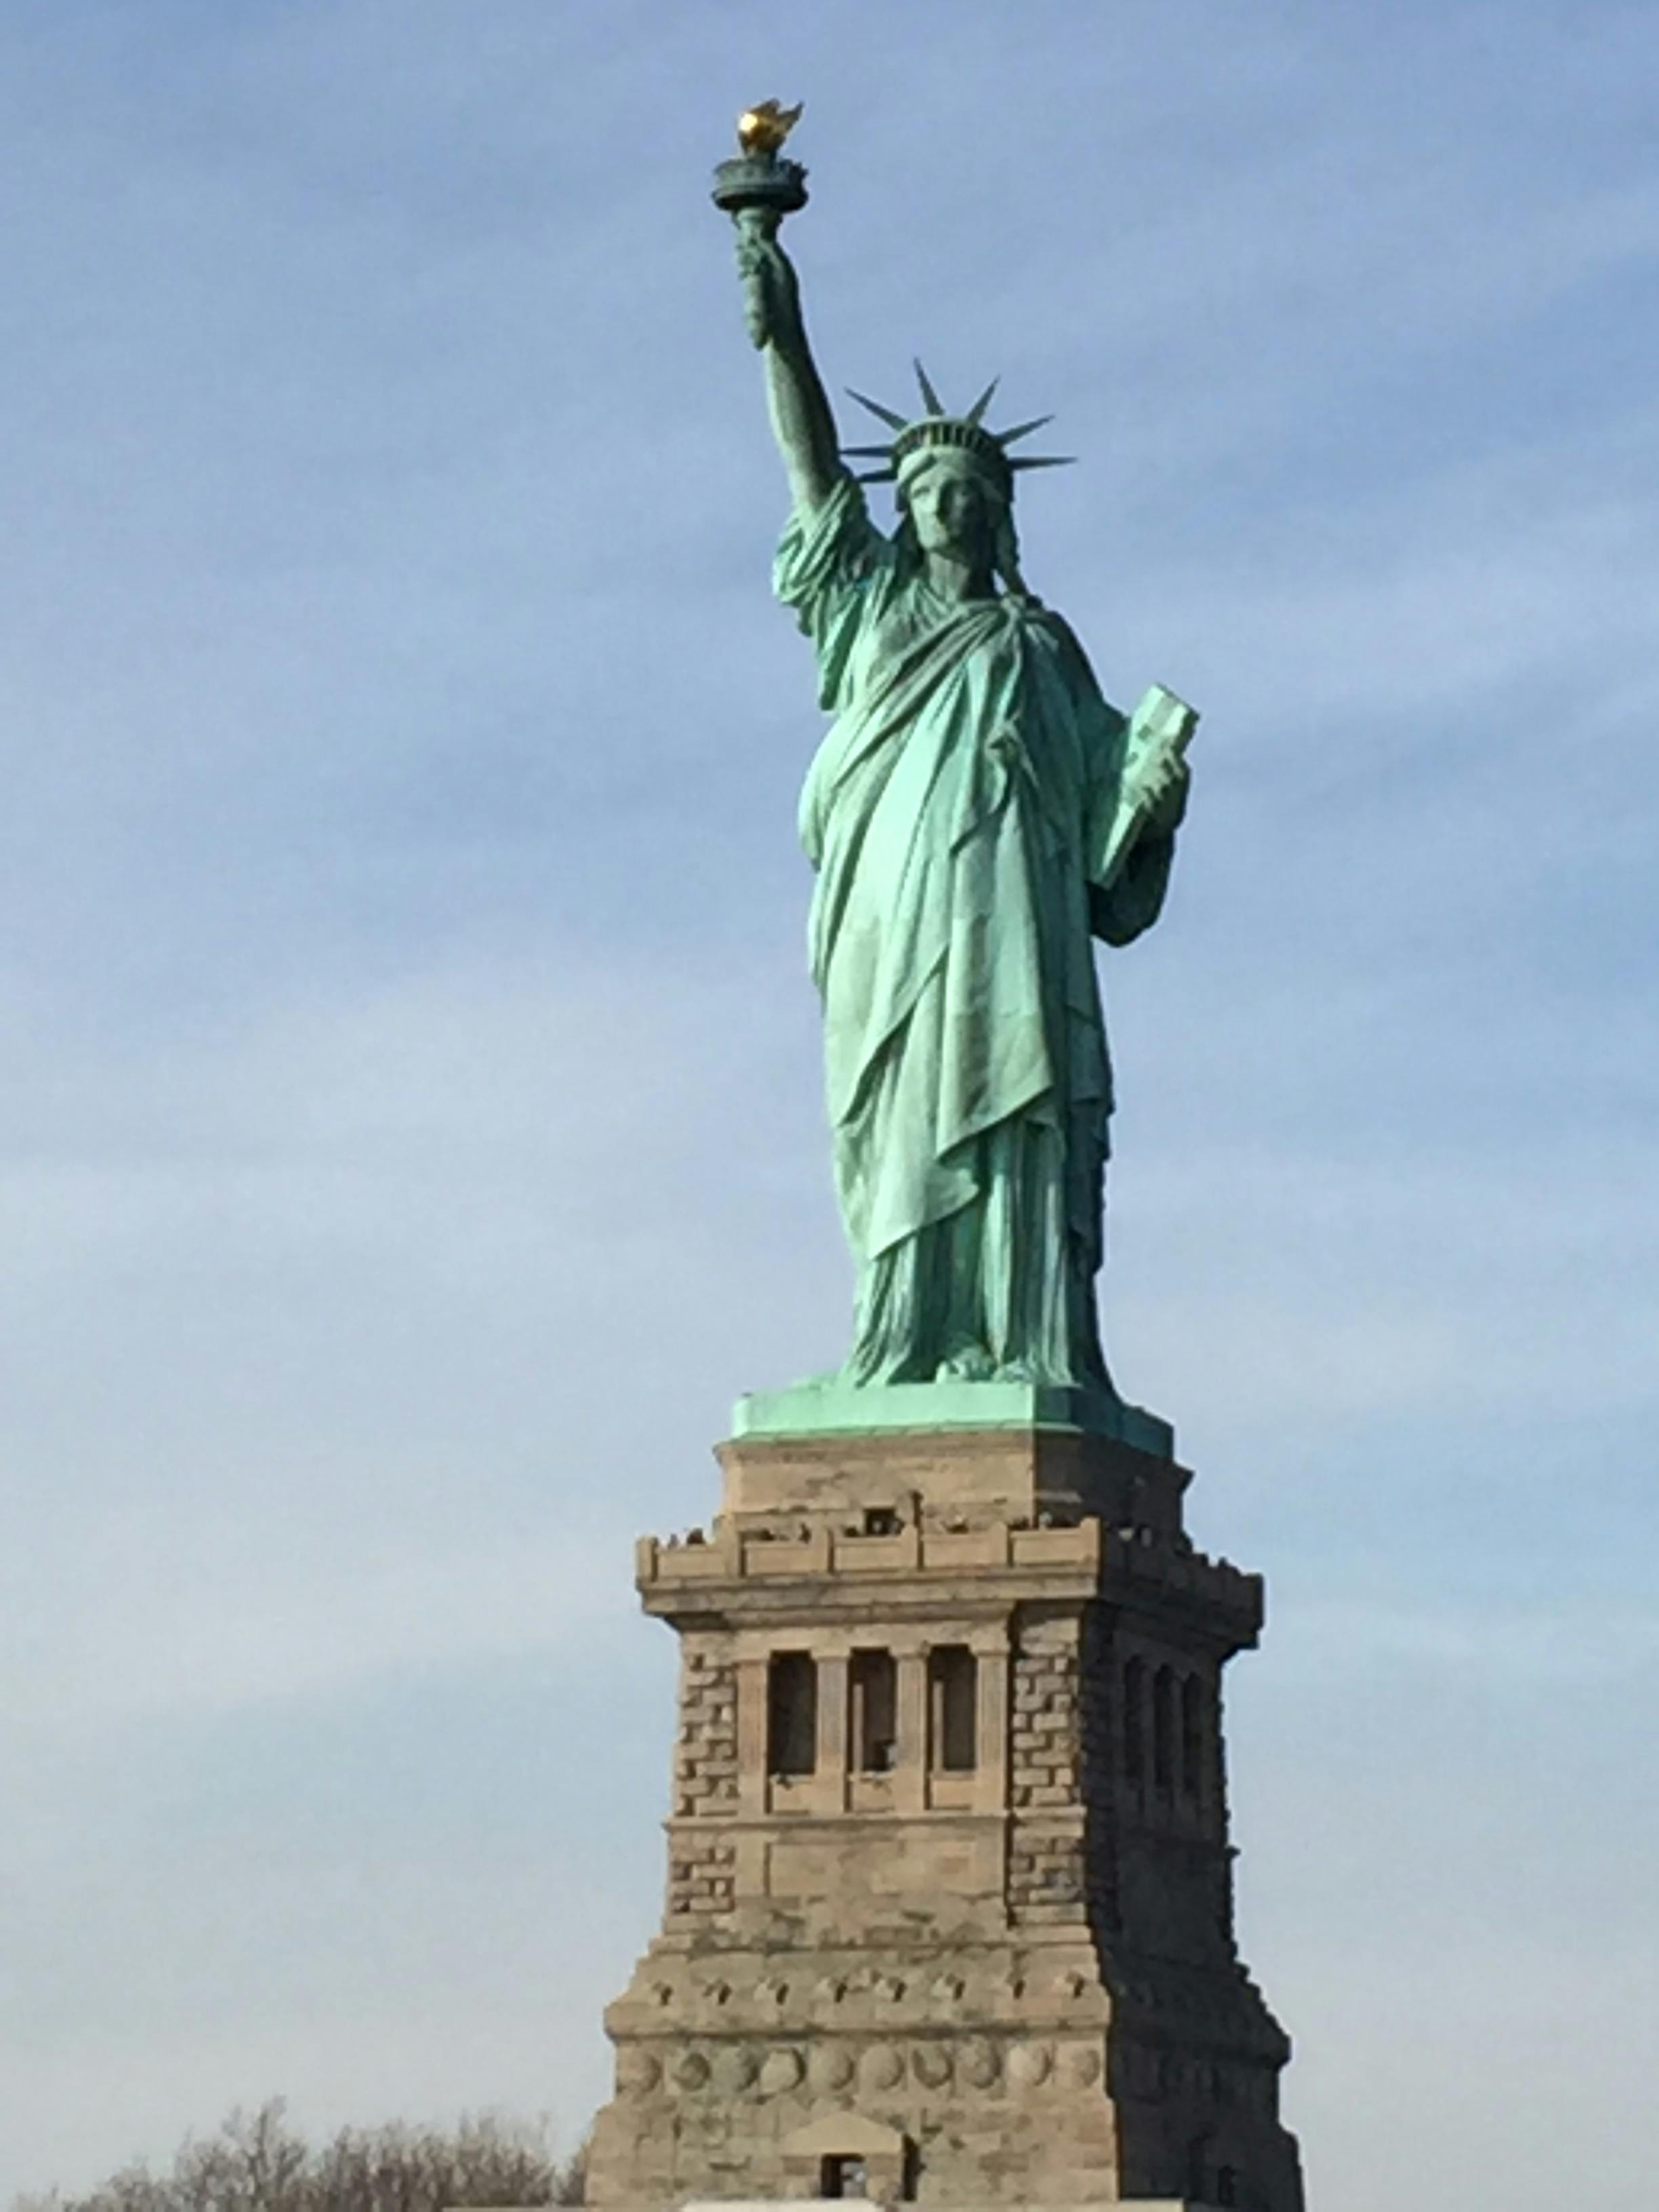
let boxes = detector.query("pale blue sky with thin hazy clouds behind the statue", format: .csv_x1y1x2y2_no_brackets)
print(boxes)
0,0,1659,2212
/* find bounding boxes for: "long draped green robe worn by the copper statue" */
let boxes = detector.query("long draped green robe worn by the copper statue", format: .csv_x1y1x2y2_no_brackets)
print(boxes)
777,478,1170,1382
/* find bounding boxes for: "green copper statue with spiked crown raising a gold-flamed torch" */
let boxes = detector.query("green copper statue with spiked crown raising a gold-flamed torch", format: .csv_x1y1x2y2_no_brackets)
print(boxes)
714,102,1195,1393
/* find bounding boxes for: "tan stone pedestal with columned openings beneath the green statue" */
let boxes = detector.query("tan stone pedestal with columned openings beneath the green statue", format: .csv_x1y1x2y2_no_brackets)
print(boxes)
588,1429,1303,2212
